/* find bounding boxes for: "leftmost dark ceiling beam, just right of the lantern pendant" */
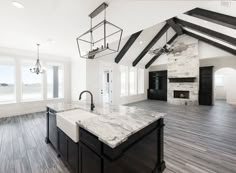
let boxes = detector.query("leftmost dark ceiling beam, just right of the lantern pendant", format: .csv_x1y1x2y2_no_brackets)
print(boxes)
115,31,142,63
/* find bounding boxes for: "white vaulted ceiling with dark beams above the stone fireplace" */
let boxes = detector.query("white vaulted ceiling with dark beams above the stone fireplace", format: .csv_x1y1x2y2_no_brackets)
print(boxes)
109,1,236,68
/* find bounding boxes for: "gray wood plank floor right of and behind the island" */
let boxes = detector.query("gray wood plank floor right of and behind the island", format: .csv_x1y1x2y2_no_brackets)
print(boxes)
130,101,236,173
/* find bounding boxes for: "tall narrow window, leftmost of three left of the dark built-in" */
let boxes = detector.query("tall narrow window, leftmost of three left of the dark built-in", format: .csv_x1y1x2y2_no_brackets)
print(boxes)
120,66,129,96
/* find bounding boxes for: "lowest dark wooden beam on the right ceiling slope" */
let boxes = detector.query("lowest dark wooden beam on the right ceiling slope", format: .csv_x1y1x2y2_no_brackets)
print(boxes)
184,30,236,55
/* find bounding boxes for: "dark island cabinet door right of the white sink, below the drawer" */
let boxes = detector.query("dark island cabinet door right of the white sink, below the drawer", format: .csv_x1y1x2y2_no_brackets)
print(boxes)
79,142,102,173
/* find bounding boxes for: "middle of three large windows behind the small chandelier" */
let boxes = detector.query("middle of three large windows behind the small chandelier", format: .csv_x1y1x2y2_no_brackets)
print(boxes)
21,63,43,101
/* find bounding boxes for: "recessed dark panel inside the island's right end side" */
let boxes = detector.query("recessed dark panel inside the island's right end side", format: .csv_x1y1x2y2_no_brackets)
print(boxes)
104,131,157,173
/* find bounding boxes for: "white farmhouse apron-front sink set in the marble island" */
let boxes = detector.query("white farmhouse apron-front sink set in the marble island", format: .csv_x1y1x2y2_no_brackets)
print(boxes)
57,109,97,143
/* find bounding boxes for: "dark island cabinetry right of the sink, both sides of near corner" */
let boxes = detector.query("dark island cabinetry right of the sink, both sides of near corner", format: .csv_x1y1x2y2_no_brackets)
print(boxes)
79,119,165,173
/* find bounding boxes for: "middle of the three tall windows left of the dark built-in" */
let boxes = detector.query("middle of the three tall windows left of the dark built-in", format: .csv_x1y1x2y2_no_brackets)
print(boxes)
129,67,137,95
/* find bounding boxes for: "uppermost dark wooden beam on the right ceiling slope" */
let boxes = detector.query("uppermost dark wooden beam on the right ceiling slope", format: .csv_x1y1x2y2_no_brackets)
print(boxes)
186,8,236,29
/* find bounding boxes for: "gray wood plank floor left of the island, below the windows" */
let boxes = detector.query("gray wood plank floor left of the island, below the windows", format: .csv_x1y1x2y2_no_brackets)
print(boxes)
0,113,69,173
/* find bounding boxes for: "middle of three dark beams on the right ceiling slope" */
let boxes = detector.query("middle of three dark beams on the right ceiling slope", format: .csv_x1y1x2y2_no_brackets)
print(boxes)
174,18,236,46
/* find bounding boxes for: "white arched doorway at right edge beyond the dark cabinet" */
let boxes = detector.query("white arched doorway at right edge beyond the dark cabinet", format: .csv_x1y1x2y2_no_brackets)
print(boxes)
214,68,236,105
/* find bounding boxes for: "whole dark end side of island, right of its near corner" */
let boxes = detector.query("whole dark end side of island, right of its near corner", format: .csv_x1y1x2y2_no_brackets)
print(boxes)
103,119,165,173
